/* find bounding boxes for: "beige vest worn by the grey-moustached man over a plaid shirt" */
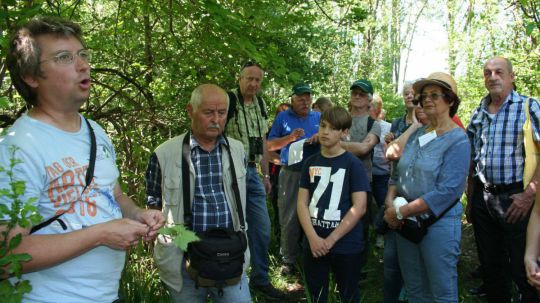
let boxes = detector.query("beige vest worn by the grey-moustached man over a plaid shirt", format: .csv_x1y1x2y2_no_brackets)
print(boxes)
154,134,249,291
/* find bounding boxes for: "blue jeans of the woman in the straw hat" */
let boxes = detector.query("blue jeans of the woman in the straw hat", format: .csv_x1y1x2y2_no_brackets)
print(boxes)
396,203,463,303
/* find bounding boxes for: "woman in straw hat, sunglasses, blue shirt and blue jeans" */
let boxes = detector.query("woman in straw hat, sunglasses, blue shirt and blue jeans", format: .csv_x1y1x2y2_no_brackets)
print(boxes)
384,73,470,303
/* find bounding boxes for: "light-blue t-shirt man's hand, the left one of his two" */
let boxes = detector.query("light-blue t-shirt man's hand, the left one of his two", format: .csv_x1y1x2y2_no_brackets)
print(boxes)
95,218,150,250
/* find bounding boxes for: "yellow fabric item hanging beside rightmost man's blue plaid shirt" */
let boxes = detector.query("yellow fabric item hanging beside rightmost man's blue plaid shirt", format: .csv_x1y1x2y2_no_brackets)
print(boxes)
523,98,540,189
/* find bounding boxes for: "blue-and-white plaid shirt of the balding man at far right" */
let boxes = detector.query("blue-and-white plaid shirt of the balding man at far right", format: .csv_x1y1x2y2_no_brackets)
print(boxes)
467,91,540,185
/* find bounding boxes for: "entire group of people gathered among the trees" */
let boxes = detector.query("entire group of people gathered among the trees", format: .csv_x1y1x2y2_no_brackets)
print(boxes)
0,17,540,303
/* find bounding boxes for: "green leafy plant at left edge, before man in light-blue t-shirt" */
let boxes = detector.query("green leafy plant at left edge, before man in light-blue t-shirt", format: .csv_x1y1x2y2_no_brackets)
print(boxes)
0,146,42,302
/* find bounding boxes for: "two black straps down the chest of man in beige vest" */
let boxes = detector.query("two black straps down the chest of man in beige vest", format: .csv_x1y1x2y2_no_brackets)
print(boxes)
182,132,246,231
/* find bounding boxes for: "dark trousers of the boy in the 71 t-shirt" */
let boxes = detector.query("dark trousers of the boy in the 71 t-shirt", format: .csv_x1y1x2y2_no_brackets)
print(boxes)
304,245,362,303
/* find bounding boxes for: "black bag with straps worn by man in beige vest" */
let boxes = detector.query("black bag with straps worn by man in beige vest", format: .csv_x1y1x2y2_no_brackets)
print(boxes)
182,133,247,296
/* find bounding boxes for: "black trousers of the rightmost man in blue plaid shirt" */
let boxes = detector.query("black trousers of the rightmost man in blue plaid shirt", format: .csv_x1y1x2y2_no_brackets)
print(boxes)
471,180,539,303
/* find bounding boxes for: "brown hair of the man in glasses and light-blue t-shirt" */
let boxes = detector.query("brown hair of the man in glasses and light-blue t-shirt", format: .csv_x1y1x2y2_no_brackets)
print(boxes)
7,16,84,105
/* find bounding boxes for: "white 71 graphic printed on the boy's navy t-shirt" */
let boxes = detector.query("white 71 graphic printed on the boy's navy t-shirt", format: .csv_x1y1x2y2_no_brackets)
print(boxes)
309,166,345,228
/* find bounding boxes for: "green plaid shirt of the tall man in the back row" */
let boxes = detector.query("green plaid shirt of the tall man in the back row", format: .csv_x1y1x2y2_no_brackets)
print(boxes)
226,89,268,163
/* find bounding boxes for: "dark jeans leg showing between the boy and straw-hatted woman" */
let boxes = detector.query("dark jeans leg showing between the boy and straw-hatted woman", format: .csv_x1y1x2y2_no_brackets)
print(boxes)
383,230,403,303
